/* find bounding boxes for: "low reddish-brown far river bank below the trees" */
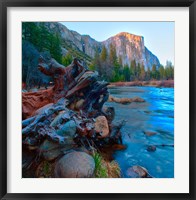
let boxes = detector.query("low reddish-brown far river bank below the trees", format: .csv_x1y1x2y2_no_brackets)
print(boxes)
108,80,174,88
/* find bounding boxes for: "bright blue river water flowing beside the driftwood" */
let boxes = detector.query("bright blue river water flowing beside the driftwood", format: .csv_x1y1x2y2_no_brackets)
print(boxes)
107,87,175,178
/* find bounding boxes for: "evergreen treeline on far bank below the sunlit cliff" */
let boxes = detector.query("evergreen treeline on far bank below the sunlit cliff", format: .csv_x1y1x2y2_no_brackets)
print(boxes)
90,44,174,82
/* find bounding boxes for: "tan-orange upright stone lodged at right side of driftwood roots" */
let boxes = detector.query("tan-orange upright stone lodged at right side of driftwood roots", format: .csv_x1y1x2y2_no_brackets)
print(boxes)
95,116,110,138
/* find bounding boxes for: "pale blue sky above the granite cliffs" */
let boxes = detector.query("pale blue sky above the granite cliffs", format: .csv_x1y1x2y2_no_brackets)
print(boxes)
61,22,175,66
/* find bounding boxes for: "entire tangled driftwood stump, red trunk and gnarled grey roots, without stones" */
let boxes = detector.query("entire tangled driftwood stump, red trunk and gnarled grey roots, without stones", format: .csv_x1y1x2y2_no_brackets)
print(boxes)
22,58,123,152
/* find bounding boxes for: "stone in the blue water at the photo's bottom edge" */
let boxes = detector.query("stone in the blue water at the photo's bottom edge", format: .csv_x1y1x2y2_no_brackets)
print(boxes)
126,165,148,178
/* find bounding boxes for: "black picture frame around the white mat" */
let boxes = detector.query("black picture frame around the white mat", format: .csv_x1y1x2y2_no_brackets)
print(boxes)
0,0,196,200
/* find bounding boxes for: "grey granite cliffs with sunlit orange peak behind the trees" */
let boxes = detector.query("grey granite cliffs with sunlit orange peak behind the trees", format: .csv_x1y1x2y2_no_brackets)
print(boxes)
41,22,160,69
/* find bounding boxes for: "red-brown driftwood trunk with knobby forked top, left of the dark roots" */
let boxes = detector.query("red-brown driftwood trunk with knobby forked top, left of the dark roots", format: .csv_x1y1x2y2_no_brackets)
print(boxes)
22,58,87,119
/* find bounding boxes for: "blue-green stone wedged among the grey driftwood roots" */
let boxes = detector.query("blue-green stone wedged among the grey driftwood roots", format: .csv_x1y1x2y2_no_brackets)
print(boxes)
56,120,76,138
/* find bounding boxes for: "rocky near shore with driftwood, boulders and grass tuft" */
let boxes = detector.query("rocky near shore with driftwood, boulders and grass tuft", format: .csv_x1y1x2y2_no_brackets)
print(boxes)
22,58,125,178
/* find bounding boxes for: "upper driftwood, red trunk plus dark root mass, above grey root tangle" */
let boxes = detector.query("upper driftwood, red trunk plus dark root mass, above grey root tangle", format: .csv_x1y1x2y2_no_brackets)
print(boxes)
22,58,108,119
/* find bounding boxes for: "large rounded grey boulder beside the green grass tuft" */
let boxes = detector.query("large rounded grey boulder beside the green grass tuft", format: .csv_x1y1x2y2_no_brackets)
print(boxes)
54,151,95,178
